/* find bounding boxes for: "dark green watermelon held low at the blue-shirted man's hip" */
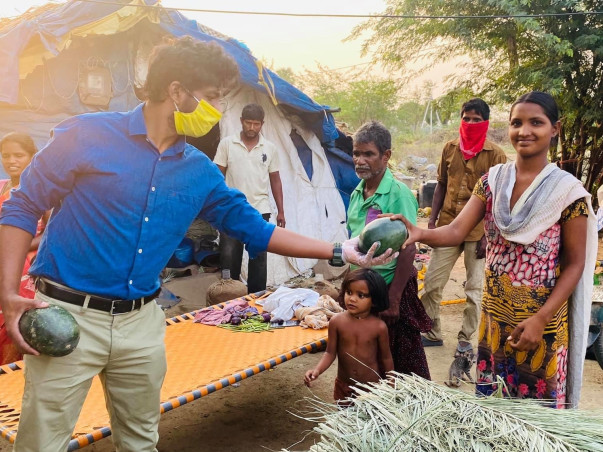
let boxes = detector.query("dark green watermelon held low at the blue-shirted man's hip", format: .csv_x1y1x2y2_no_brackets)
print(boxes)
19,305,80,356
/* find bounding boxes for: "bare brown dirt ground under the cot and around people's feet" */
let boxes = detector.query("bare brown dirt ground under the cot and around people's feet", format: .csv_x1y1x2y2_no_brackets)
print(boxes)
0,235,603,452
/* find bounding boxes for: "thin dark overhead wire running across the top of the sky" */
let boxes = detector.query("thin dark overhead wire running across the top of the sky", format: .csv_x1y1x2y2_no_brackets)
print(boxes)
79,0,603,20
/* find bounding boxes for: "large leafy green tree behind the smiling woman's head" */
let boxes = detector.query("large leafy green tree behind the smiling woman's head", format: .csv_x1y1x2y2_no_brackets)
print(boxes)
351,0,603,191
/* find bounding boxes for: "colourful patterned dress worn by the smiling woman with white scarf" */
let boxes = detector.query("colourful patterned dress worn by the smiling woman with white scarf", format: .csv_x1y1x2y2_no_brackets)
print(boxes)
473,174,588,408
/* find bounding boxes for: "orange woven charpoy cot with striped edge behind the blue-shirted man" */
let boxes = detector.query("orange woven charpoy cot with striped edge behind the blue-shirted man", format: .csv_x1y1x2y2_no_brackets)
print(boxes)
0,296,327,451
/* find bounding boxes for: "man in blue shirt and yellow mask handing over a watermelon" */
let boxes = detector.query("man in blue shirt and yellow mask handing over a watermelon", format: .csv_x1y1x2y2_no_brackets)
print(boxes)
0,37,393,452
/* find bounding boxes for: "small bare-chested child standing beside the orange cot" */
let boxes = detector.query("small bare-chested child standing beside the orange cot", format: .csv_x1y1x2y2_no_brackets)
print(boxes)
304,268,394,403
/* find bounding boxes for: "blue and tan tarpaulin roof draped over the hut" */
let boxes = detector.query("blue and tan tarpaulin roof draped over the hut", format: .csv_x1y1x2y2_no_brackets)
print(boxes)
0,0,358,207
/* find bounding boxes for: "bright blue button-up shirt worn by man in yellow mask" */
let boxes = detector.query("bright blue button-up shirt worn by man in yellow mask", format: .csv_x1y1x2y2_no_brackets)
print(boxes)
0,104,274,299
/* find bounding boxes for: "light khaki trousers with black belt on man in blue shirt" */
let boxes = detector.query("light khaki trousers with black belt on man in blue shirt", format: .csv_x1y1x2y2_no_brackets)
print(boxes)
13,293,167,452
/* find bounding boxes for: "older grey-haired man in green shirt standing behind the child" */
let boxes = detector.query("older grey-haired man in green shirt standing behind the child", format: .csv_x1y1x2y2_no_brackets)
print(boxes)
348,121,431,379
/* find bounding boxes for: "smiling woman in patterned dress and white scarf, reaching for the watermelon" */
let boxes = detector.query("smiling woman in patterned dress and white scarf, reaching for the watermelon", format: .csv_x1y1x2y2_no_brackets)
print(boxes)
395,91,596,408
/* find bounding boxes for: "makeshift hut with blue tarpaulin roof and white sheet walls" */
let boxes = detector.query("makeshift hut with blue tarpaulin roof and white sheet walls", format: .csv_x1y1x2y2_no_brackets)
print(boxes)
0,0,358,284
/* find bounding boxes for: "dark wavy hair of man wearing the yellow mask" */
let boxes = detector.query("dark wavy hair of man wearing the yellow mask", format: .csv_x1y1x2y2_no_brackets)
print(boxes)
144,36,239,102
